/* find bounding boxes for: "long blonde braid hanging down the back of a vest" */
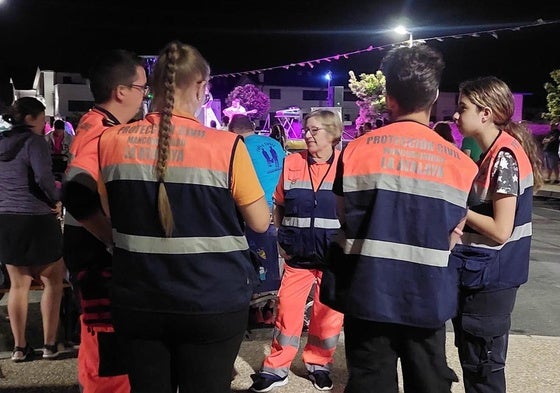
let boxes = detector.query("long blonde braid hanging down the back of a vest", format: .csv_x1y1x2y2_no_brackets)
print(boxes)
155,43,179,237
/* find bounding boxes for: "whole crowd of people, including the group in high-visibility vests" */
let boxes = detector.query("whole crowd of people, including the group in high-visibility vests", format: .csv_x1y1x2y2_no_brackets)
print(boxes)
0,41,559,393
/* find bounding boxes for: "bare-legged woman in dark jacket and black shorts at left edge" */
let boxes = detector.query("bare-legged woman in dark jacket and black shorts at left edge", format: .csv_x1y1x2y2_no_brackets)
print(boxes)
0,97,65,362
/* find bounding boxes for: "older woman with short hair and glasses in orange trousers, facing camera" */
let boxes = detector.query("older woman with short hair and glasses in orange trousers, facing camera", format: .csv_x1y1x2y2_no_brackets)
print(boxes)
250,110,343,392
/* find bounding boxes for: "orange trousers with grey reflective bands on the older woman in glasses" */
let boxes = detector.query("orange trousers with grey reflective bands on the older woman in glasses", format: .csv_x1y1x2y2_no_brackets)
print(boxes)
261,265,344,377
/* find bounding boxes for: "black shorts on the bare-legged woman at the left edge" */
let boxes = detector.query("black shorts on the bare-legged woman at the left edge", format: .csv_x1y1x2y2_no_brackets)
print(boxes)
0,214,62,266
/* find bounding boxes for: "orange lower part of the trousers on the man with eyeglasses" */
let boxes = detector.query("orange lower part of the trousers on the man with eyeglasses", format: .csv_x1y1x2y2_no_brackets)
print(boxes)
78,315,130,393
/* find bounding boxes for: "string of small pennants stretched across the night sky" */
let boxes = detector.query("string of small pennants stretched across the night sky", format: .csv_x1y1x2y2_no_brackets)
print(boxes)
212,19,560,78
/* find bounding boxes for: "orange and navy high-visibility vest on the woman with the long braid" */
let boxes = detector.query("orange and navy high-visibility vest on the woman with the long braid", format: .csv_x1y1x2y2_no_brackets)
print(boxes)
99,113,258,314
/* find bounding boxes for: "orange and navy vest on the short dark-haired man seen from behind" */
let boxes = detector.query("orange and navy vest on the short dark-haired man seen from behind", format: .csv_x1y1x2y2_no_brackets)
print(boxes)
335,121,477,328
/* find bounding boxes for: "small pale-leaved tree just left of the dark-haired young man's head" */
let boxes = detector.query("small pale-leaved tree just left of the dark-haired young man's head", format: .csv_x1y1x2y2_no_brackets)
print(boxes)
348,70,386,127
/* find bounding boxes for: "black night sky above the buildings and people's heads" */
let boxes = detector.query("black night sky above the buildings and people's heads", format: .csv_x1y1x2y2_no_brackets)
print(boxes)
0,0,560,116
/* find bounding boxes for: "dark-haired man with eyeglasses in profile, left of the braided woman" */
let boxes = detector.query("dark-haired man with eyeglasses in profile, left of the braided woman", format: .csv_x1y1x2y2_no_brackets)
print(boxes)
63,50,149,393
